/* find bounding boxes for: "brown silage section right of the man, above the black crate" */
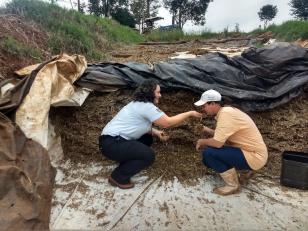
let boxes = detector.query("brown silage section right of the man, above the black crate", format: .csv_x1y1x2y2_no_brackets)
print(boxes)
251,91,308,176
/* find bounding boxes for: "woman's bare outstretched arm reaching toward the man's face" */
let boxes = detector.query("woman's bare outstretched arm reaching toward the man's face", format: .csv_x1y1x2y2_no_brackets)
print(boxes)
153,111,202,128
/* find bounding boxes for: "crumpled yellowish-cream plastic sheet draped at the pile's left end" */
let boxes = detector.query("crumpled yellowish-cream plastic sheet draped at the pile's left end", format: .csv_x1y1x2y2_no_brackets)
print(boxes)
16,54,87,148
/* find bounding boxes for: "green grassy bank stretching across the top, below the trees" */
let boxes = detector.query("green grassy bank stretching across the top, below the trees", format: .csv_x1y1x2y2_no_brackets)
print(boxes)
0,0,308,61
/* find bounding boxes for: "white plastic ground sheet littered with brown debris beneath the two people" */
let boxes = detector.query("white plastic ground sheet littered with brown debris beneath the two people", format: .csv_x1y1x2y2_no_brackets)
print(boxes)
50,161,308,231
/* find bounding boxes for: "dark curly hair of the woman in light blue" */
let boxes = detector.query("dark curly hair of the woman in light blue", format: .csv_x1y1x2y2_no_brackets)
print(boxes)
133,79,158,103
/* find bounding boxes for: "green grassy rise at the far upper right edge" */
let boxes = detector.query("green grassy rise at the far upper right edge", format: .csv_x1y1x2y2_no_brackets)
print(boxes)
251,21,308,42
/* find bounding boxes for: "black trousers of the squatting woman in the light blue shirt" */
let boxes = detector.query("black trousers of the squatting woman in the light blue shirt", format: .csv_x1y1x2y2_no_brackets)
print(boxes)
99,134,155,184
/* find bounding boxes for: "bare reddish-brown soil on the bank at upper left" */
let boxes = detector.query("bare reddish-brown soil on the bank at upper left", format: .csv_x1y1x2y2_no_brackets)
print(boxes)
0,15,50,78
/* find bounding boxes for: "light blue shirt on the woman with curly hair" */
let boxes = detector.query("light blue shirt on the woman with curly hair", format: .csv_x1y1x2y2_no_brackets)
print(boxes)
102,101,165,140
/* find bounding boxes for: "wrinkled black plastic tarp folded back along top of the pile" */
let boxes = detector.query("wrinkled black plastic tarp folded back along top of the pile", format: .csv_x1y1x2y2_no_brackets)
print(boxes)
77,43,308,111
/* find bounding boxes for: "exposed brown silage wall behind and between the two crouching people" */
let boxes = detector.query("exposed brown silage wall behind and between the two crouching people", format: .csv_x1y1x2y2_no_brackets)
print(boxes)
52,90,308,183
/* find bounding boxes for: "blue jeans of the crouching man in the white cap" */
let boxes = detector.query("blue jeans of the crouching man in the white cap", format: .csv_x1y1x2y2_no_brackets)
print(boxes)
202,146,251,173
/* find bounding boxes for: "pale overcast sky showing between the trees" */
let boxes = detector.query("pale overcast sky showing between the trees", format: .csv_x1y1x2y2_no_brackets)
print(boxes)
0,0,292,32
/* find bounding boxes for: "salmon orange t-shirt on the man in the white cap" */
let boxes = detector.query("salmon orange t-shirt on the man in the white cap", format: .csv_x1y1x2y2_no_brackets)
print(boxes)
213,106,268,170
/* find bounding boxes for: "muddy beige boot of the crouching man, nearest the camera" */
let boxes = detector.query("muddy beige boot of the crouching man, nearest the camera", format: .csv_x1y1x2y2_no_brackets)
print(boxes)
213,168,241,196
